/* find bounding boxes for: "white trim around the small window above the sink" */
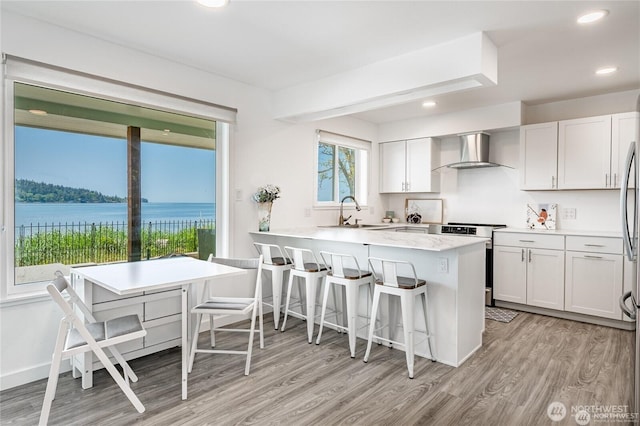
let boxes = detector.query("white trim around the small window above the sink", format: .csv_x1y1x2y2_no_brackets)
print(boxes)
313,129,372,209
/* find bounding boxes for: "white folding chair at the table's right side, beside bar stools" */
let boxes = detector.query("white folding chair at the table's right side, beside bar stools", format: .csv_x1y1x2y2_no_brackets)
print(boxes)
188,255,264,376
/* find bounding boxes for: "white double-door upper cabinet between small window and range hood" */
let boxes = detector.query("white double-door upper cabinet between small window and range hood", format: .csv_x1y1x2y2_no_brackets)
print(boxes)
380,138,440,192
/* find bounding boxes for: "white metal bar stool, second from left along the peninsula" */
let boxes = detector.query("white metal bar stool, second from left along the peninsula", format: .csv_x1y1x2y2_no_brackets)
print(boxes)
282,246,327,343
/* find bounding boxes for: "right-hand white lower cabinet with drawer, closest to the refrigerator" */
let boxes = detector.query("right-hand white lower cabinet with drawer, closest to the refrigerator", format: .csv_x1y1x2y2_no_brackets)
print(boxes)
565,236,623,320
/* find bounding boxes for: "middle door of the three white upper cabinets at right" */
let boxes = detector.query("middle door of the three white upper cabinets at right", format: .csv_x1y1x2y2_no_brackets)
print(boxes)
558,115,613,189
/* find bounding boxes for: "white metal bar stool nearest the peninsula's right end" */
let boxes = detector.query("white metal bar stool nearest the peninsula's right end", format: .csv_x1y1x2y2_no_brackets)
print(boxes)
364,257,435,379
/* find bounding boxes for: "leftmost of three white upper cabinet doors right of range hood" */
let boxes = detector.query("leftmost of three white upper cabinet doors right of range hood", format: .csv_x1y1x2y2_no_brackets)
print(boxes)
520,121,558,189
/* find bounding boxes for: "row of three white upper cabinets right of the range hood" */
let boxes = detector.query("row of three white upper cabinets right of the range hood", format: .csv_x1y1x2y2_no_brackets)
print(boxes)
520,112,638,190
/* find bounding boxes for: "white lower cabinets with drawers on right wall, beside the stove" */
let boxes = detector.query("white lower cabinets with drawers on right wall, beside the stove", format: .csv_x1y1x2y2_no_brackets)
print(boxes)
493,233,629,320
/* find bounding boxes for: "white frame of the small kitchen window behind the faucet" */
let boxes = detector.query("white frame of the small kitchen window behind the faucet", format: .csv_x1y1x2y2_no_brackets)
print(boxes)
313,129,372,209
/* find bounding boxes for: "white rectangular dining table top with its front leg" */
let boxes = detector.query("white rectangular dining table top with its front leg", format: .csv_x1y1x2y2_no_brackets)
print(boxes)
70,256,247,399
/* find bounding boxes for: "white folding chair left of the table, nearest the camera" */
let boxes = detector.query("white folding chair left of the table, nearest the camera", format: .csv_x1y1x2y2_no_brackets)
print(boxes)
40,271,147,425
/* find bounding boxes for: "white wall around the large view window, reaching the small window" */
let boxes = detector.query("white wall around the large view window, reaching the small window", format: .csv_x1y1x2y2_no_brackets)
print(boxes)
0,11,379,389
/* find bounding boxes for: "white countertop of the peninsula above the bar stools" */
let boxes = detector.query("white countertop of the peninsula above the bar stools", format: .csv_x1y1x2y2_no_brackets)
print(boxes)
251,223,487,251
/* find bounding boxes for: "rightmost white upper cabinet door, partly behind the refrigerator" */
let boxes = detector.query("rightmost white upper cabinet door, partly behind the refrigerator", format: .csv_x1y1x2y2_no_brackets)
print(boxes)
611,111,640,188
